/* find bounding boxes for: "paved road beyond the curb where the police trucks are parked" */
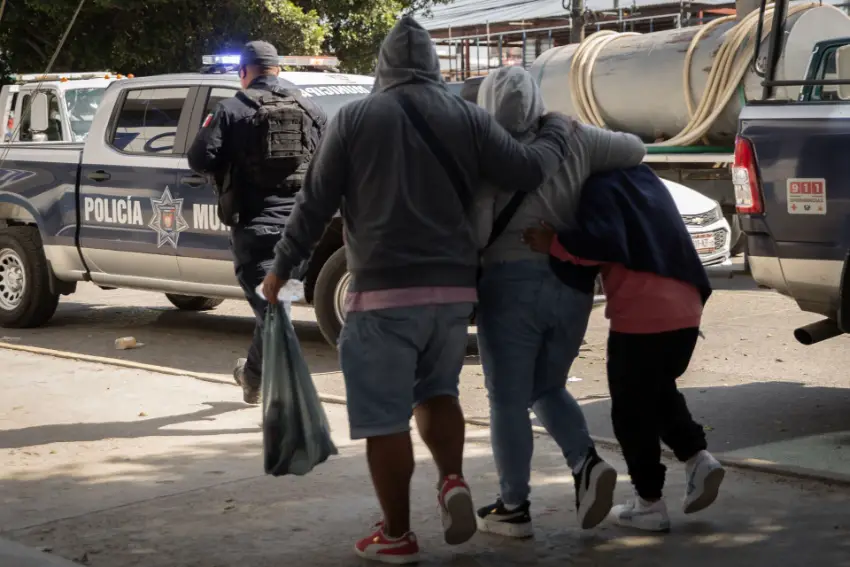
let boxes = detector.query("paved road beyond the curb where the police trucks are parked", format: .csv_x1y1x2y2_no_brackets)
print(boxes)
0,268,850,473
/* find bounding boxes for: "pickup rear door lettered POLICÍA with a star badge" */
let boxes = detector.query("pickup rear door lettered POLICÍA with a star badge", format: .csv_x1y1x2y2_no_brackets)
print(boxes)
79,85,198,291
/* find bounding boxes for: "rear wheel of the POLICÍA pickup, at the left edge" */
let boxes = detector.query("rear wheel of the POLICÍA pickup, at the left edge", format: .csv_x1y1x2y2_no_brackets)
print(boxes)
0,226,59,329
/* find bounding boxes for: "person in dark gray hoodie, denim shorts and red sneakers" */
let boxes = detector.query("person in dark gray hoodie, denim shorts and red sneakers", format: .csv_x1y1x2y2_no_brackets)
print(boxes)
264,17,569,564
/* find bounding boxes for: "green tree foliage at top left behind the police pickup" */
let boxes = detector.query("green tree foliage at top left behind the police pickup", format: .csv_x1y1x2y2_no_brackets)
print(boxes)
0,0,450,75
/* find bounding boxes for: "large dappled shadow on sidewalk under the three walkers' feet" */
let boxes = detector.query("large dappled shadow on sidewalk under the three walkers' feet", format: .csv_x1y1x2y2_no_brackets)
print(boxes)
3,430,850,567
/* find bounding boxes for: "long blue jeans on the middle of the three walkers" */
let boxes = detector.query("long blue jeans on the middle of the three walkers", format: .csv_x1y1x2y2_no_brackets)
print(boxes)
477,260,593,505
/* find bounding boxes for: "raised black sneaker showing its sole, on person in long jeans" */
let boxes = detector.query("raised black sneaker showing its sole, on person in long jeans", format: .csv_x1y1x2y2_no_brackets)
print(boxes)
573,448,617,530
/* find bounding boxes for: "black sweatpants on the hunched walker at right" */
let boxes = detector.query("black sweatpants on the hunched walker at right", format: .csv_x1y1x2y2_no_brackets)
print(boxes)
608,328,707,500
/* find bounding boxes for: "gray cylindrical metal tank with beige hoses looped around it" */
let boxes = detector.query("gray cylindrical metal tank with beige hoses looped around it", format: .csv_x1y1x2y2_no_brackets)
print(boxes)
530,7,850,146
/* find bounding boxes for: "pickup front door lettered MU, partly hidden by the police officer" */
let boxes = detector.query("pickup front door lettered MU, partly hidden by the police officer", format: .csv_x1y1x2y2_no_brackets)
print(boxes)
172,85,242,290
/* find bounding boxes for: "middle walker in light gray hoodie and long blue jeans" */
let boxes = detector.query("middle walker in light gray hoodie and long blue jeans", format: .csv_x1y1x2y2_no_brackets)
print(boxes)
475,67,646,537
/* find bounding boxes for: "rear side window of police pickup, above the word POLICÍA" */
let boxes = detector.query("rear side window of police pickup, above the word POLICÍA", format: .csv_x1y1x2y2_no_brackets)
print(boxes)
109,87,189,155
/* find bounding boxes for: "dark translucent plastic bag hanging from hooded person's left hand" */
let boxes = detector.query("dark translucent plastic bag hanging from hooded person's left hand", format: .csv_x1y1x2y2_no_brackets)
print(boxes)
262,304,337,476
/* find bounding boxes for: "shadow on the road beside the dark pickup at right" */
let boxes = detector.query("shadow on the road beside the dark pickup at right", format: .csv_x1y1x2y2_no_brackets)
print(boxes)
548,382,850,452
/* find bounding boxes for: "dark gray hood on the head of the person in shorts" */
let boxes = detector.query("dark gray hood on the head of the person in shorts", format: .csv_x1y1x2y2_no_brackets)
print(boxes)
372,16,445,92
